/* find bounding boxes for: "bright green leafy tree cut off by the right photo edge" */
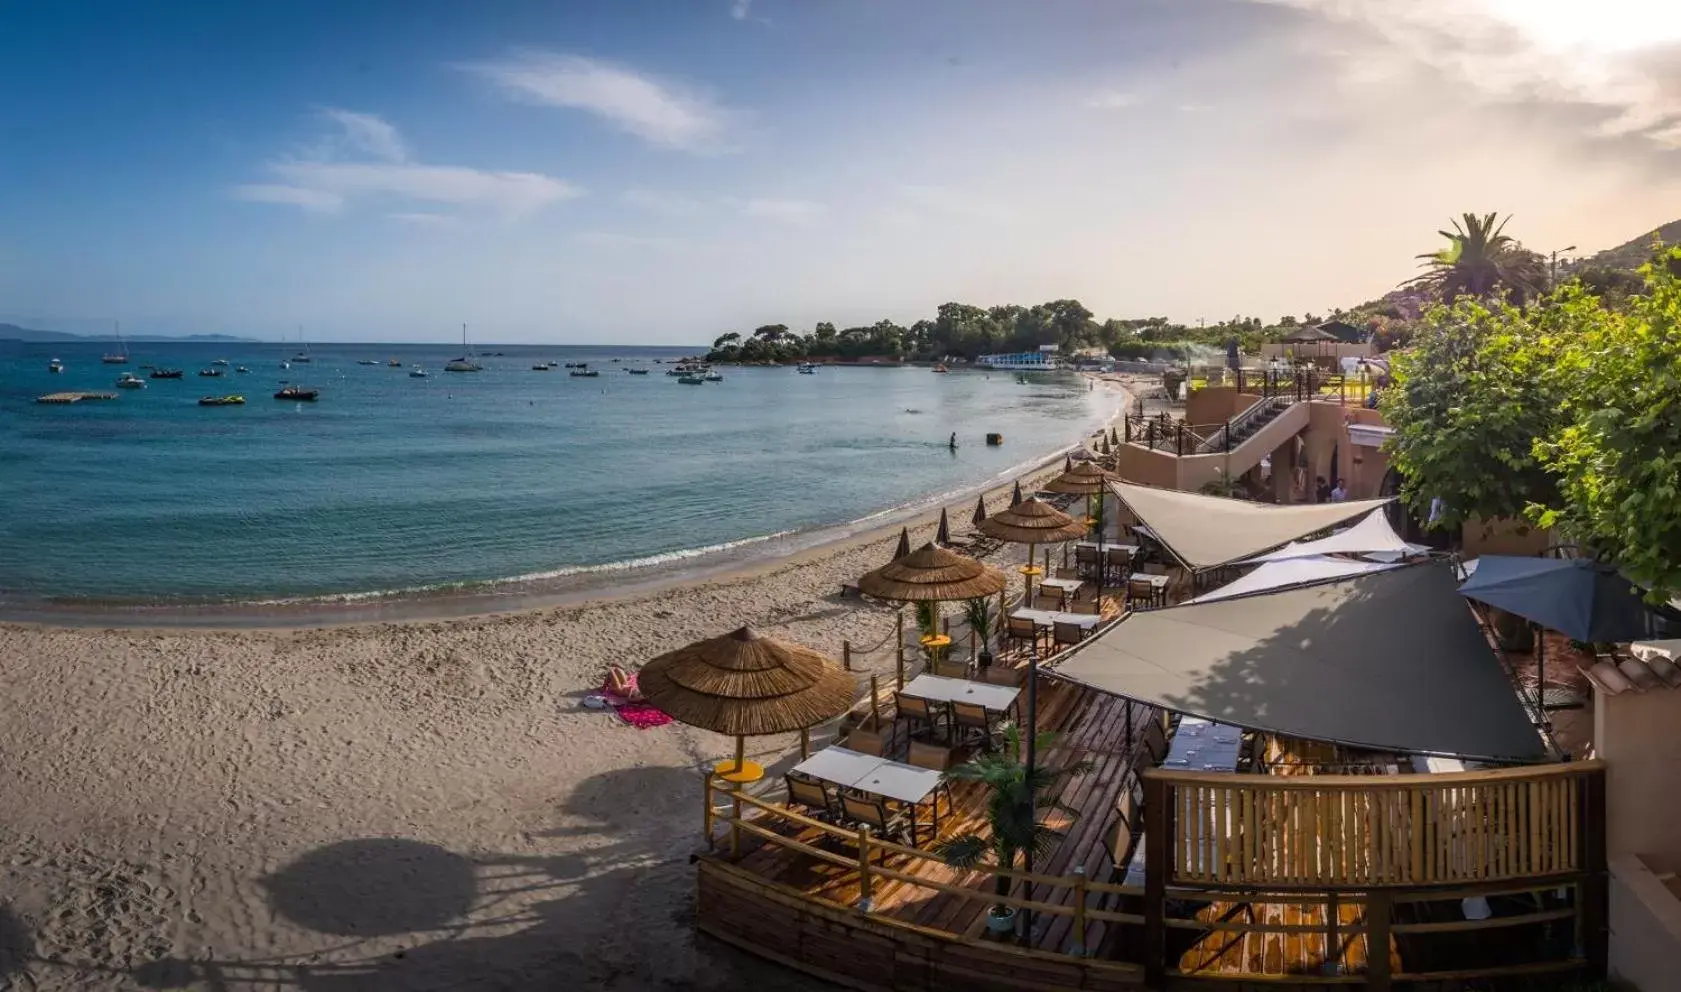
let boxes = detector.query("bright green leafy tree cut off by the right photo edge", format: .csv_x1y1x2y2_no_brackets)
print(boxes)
1531,251,1681,599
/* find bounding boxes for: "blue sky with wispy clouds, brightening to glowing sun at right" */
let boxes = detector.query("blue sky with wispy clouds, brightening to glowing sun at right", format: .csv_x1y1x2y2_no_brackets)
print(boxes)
0,0,1681,345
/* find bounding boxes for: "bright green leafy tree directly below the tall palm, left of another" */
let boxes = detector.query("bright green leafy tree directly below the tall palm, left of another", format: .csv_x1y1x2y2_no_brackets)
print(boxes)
1378,298,1570,528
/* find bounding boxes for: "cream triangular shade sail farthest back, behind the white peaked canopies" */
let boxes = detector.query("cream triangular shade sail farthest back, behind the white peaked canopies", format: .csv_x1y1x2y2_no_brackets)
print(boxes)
1111,483,1390,568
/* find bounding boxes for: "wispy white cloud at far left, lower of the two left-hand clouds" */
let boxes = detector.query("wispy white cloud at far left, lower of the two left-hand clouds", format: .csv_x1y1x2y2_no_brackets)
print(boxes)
232,111,583,224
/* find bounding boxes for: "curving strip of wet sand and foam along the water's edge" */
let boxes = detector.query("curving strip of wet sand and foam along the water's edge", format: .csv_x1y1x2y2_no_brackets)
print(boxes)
0,373,1135,631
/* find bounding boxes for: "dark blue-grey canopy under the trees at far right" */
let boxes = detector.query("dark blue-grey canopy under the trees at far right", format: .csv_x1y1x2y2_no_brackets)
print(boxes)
1459,555,1652,642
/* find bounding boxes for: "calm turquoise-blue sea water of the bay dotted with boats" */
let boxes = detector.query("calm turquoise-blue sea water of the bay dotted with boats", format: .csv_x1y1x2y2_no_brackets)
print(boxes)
0,343,1115,605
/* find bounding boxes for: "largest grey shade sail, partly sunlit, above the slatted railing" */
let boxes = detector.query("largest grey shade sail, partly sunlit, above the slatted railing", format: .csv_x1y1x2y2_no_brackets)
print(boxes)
1049,562,1547,762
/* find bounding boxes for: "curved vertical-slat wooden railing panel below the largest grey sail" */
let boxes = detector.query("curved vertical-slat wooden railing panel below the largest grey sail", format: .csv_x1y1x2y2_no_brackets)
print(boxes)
1146,762,1600,888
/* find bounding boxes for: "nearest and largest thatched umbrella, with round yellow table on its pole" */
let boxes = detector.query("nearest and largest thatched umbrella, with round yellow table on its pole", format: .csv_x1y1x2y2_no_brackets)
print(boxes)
637,627,852,780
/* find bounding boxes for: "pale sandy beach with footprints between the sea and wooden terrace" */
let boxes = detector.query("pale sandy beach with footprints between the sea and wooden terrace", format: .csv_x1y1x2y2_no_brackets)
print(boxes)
0,381,1143,990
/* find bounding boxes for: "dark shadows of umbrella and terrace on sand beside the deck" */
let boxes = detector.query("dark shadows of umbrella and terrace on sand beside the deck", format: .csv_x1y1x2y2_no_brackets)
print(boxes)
133,767,819,992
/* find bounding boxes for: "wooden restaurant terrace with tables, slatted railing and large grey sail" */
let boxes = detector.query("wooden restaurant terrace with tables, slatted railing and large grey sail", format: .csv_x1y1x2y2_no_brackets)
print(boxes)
696,514,1605,990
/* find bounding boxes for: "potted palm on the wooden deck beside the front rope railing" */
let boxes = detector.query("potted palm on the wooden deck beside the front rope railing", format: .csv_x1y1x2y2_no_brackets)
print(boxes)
935,723,1091,933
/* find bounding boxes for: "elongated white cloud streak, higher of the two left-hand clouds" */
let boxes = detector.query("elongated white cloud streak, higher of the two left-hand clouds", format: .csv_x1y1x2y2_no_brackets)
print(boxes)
464,52,731,151
